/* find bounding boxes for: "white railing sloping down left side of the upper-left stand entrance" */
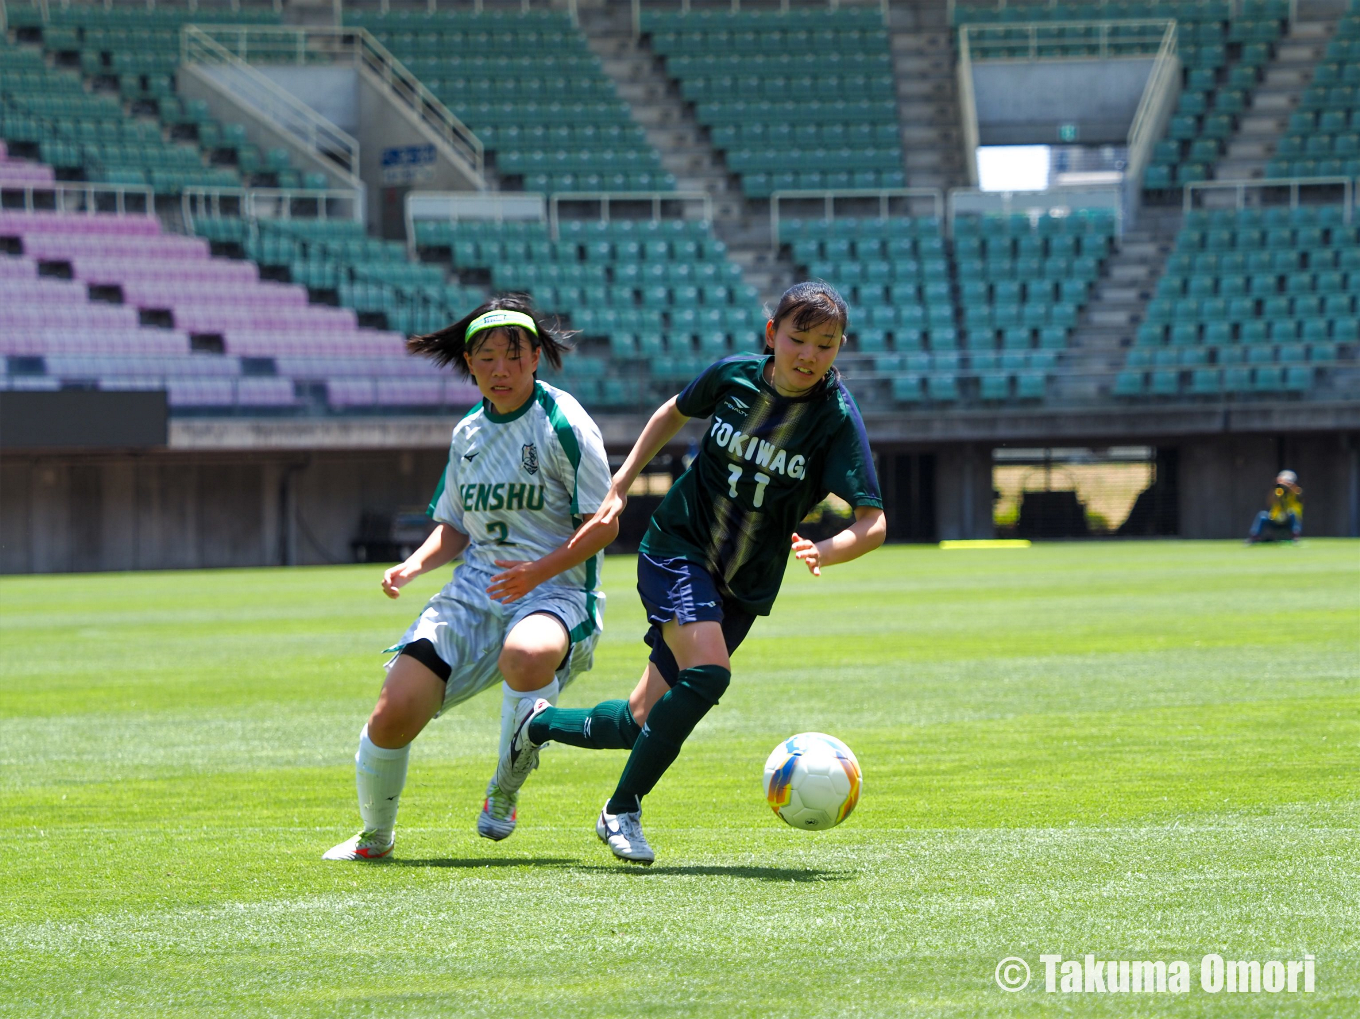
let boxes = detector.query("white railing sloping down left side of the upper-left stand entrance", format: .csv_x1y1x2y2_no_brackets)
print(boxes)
180,24,359,177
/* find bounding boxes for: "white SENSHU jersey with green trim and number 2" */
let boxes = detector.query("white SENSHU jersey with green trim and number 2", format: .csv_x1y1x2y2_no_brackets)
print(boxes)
430,382,611,604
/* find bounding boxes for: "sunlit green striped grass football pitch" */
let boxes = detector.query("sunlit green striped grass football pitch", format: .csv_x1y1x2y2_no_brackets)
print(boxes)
0,540,1360,1019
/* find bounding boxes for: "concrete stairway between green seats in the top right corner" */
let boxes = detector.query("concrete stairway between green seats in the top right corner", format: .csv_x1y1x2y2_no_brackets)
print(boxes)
1213,11,1337,181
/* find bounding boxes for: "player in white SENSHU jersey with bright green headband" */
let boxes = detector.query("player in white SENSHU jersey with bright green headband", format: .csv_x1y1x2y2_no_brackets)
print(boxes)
324,295,617,860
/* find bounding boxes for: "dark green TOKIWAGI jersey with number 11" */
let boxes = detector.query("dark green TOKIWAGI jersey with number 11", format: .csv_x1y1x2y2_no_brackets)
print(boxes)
642,355,883,615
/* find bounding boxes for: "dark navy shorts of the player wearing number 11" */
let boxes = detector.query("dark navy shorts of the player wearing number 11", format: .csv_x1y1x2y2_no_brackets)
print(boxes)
638,552,756,686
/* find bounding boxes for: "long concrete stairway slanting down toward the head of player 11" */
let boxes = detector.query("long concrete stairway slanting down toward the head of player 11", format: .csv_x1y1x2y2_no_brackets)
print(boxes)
581,4,793,302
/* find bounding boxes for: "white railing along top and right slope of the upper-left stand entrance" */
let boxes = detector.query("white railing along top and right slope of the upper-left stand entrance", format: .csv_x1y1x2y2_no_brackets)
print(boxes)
189,24,486,180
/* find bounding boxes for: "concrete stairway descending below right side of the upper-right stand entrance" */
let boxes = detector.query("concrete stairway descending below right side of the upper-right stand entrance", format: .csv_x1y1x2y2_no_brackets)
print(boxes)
1051,205,1180,403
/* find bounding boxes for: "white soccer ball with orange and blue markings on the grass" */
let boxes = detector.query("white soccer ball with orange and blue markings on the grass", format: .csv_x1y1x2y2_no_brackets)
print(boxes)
766,732,862,831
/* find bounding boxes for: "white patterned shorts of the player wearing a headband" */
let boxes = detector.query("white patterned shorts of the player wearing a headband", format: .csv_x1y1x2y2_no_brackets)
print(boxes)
388,566,604,713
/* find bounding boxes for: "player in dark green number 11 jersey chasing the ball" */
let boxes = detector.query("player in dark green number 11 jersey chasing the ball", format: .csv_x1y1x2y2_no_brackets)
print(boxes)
496,282,887,864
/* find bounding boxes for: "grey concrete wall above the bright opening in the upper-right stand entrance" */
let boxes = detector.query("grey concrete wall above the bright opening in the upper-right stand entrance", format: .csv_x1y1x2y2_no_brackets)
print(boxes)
972,57,1153,146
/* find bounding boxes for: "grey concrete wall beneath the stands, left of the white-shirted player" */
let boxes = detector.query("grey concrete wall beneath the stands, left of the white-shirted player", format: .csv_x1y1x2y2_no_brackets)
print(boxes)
0,450,446,573
